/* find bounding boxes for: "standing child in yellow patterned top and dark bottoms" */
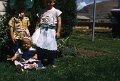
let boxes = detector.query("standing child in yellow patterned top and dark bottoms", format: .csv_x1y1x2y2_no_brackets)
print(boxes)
8,12,30,52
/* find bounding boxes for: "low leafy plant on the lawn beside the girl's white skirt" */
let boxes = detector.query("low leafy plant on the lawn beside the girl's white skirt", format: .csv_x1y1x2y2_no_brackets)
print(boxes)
57,36,77,57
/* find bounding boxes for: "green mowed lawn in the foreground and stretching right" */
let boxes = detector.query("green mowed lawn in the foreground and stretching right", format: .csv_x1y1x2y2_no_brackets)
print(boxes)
0,31,120,81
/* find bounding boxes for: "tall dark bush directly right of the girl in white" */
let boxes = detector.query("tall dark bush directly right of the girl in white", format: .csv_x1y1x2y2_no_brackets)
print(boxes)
56,0,77,37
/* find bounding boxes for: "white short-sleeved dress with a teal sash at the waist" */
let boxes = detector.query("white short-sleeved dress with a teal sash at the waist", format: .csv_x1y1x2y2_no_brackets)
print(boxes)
32,7,62,50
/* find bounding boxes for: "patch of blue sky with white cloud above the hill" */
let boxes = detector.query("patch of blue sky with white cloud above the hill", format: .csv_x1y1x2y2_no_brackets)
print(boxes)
76,0,110,11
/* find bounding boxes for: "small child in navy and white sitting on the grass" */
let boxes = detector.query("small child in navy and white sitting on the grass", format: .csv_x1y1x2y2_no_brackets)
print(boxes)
11,37,45,71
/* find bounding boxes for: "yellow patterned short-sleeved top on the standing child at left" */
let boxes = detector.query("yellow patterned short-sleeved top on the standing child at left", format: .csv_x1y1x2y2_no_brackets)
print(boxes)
9,17,30,39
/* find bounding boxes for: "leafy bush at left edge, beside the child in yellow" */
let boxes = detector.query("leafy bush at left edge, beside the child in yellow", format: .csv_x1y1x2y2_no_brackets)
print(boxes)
0,16,10,60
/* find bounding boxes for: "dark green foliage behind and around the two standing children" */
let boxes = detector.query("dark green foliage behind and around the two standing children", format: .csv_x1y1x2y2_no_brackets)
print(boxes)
0,0,77,59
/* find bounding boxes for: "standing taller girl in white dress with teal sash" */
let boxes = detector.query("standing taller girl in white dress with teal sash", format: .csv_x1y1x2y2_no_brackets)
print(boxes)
32,0,62,67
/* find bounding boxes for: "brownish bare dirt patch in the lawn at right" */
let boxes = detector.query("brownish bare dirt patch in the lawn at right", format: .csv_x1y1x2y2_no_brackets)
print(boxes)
77,48,110,57
